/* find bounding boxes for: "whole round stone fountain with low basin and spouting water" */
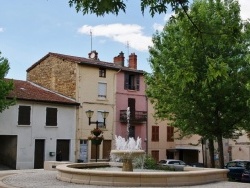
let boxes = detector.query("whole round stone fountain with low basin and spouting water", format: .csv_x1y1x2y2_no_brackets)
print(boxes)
56,107,228,187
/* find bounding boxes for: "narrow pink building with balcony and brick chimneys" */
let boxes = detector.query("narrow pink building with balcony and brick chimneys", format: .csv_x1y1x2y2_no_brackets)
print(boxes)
114,52,147,150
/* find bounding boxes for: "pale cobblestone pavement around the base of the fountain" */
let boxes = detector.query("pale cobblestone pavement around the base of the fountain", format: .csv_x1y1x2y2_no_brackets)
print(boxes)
0,170,250,188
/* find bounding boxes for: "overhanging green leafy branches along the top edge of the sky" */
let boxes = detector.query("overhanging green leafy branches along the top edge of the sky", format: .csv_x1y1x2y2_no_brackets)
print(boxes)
69,0,189,16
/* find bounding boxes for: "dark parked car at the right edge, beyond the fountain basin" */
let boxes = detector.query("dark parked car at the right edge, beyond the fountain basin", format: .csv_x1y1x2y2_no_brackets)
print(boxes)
225,160,250,181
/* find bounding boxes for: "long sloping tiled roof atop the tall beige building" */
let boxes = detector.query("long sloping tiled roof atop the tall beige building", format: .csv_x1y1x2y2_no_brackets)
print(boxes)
27,52,144,74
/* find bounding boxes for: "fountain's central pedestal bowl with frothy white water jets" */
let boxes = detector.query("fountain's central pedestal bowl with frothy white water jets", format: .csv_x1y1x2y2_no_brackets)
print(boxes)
110,136,145,171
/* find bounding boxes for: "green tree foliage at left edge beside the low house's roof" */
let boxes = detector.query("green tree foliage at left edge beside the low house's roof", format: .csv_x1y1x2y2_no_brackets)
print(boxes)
0,52,15,113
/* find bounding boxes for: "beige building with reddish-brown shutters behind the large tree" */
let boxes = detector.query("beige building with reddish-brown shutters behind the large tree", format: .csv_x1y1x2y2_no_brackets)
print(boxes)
147,98,250,167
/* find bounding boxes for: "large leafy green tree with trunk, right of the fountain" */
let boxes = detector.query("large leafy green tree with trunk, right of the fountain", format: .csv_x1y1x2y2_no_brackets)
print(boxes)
146,0,250,168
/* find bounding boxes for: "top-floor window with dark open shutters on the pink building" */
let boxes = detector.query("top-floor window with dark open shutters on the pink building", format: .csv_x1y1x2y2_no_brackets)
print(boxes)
124,73,140,91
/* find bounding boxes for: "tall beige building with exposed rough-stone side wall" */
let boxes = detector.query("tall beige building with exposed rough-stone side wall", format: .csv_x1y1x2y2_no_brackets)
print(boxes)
27,52,118,162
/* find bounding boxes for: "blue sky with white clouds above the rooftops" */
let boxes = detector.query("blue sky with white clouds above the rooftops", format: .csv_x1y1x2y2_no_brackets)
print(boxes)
0,0,250,80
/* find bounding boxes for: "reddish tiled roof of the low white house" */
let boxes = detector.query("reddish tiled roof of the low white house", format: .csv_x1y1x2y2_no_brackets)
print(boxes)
6,79,79,106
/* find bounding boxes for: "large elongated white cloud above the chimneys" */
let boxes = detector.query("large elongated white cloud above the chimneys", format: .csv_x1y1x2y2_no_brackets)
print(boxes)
78,24,152,51
